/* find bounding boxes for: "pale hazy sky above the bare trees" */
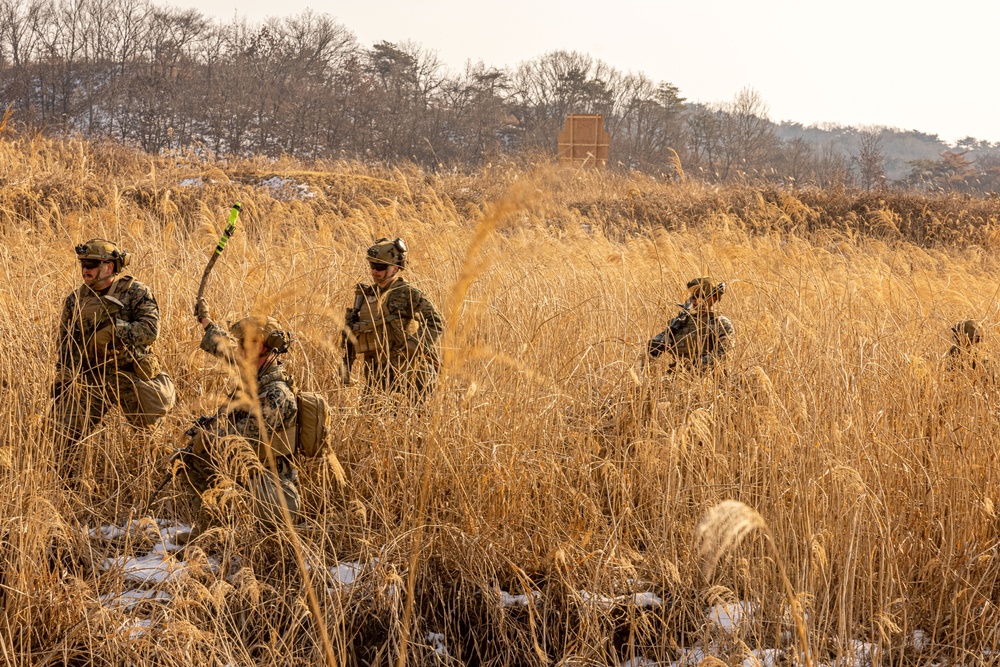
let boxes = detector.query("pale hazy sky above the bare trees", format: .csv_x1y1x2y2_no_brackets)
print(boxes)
178,0,1000,143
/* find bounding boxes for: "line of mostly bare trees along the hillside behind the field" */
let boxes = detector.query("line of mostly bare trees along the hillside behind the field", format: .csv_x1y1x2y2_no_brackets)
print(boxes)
0,0,1000,192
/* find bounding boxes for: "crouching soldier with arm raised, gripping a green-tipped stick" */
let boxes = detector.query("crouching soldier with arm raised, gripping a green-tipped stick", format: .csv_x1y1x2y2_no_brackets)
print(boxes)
179,308,301,528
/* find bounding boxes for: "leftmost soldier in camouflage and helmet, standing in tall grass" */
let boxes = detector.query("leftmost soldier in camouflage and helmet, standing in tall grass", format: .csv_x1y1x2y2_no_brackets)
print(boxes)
52,238,176,455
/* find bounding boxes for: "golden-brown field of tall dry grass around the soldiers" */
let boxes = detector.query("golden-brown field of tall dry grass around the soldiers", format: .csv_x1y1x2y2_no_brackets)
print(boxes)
0,135,1000,667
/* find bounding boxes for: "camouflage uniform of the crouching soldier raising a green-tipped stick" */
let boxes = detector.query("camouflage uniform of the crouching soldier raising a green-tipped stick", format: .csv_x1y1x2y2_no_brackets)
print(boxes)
181,318,301,528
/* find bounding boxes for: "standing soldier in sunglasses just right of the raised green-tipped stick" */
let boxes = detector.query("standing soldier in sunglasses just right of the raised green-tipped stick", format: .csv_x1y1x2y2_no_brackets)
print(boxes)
342,238,444,400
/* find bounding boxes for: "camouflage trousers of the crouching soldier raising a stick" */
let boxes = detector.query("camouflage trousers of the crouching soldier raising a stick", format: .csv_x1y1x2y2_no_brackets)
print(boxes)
177,437,302,530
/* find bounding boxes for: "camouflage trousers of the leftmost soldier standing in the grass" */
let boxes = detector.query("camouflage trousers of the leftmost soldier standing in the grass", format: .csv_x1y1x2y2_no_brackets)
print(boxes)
51,371,177,444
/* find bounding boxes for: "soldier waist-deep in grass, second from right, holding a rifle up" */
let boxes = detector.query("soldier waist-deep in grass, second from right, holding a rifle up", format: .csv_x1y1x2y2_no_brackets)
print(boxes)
646,277,735,370
